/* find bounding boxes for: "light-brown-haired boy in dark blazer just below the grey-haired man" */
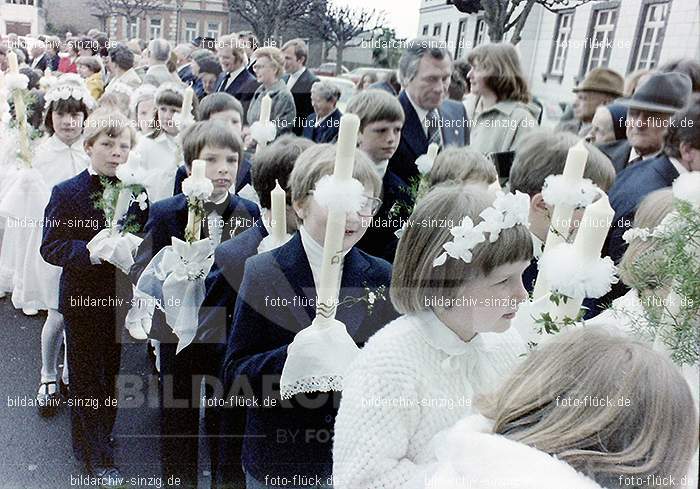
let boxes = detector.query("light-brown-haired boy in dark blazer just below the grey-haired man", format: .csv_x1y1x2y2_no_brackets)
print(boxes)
347,89,414,262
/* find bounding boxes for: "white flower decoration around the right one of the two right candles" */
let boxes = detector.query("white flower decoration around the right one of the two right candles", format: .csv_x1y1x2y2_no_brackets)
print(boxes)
539,243,618,299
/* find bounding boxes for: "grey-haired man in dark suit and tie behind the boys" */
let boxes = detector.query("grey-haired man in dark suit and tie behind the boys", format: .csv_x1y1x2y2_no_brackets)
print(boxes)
389,37,469,183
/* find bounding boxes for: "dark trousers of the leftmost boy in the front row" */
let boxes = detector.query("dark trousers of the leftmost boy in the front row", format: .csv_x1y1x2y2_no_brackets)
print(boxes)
64,309,121,469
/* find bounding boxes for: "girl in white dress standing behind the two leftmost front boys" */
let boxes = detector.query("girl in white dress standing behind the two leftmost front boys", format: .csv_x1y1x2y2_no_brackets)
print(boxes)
134,83,191,202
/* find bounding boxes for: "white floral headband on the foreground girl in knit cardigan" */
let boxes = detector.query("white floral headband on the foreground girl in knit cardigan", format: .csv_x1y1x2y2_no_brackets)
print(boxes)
433,191,530,267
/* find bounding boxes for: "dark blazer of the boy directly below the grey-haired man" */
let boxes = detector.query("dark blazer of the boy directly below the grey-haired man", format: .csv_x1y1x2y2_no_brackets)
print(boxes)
357,168,413,263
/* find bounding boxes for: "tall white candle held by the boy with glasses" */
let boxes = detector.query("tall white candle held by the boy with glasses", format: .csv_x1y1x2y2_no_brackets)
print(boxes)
316,114,360,319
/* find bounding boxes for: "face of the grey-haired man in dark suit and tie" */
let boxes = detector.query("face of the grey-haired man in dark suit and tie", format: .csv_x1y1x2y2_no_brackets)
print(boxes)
406,56,452,110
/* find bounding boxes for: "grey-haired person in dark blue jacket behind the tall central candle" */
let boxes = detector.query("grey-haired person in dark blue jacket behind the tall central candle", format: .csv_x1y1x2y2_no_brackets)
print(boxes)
304,81,343,143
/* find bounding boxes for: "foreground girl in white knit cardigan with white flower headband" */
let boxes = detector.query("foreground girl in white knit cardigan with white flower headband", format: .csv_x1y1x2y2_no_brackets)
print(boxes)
333,185,532,489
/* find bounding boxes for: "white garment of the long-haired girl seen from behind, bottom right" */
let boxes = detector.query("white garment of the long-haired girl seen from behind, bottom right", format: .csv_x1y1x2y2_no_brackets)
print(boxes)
404,415,602,489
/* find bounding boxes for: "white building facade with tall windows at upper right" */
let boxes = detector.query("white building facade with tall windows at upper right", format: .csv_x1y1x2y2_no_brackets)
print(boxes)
417,0,700,101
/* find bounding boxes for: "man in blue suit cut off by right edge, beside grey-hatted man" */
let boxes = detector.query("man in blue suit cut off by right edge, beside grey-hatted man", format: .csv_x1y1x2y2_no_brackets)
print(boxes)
608,93,700,263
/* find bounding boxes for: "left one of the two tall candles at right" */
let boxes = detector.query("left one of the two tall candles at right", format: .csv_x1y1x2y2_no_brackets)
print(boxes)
532,141,588,300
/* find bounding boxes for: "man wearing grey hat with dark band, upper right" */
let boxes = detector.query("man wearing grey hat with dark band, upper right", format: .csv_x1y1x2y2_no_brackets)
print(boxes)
599,73,691,173
